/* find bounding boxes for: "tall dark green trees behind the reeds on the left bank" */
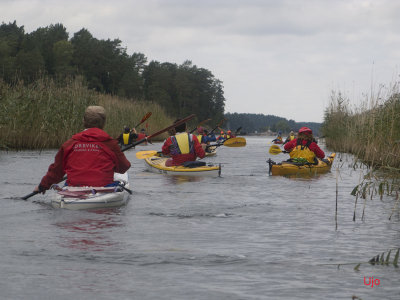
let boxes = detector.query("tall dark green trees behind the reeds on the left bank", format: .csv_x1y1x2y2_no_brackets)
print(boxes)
0,21,225,120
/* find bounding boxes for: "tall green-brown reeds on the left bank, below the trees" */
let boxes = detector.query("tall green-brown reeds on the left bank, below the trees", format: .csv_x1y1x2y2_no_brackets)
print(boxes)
0,77,173,149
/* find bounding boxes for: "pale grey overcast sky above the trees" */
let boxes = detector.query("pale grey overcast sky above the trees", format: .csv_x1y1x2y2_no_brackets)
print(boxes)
0,0,400,122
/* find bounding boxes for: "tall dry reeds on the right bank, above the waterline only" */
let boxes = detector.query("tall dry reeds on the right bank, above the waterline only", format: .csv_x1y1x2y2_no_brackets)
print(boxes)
322,84,400,170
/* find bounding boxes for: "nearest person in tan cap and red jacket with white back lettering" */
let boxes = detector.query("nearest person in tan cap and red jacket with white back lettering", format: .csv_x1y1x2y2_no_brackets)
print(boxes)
34,106,131,193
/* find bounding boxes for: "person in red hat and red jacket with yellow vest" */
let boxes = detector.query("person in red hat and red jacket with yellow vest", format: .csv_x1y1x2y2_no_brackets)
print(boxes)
284,127,325,163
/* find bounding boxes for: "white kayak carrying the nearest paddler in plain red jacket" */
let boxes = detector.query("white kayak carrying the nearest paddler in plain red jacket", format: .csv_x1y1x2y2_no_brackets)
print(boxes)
51,173,130,210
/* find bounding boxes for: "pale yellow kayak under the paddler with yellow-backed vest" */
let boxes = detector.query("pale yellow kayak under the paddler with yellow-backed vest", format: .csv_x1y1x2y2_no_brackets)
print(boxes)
144,155,221,177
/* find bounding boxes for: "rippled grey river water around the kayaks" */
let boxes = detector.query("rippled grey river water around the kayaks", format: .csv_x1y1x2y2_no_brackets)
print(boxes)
0,137,400,300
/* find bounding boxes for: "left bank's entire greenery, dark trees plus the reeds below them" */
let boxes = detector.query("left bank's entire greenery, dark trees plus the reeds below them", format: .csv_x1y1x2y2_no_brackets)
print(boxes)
0,21,225,148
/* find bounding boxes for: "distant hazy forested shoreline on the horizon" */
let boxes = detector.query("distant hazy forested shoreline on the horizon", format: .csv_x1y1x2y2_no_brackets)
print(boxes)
225,113,321,136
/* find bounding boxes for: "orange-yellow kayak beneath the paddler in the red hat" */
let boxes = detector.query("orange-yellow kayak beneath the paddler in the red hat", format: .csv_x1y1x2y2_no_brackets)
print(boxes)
267,153,336,175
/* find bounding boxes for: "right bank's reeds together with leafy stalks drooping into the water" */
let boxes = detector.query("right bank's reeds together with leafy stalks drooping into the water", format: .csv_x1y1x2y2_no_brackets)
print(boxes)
322,84,400,212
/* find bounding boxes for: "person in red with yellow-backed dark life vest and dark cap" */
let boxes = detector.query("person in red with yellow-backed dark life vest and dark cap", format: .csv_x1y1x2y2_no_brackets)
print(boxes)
162,119,206,167
